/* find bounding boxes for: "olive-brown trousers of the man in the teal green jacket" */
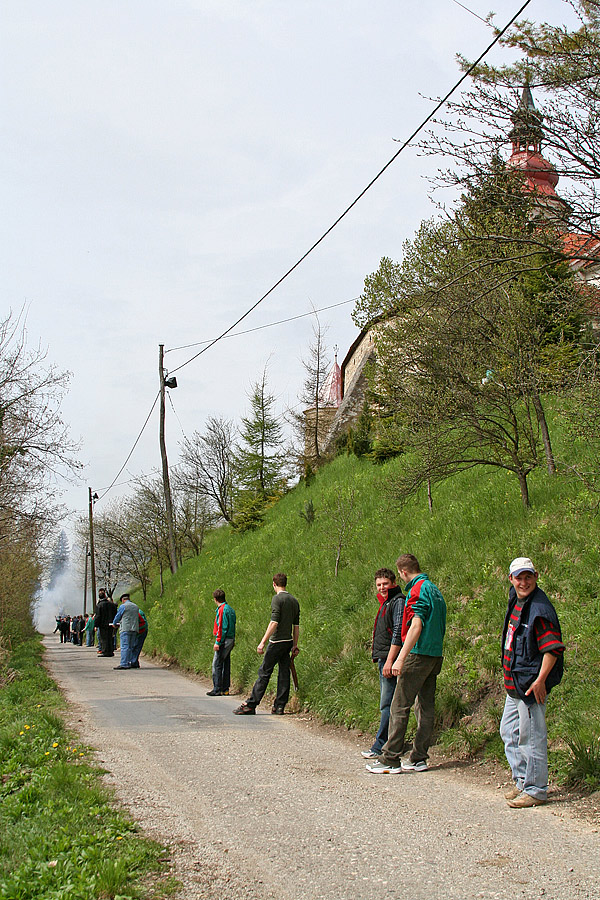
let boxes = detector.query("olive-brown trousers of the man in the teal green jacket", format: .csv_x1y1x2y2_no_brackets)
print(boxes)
380,653,443,765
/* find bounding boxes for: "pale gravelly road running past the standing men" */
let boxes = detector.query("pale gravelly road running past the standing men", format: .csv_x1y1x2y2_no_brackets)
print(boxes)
45,636,600,900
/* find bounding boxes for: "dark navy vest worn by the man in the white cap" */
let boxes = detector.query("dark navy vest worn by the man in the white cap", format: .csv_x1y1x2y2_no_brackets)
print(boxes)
502,587,564,706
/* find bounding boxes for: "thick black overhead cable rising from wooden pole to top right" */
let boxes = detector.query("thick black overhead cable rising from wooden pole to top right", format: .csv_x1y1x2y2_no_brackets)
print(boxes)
171,0,531,374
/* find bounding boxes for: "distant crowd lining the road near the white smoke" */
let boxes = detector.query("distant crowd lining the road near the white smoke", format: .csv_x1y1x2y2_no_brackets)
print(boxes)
54,588,148,670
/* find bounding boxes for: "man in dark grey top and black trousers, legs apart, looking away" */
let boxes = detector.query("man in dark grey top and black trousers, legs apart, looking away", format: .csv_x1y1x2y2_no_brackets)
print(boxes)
233,572,300,716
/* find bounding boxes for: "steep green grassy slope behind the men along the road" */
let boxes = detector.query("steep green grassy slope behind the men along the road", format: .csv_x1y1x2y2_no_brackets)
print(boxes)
145,426,600,782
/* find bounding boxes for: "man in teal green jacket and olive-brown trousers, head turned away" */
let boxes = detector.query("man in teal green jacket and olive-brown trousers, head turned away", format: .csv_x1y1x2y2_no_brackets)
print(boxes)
367,553,446,775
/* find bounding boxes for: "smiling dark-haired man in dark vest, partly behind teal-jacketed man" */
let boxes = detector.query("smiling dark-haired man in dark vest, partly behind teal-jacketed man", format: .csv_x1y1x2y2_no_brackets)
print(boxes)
361,569,404,759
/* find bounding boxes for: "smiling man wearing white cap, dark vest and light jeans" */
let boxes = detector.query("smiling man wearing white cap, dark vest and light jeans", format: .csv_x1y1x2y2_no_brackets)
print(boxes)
500,556,565,809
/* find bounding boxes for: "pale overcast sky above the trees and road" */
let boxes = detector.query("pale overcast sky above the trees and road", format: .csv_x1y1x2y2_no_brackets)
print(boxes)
0,0,573,540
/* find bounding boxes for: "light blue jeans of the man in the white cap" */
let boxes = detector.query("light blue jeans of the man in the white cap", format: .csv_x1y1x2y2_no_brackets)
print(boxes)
500,696,548,800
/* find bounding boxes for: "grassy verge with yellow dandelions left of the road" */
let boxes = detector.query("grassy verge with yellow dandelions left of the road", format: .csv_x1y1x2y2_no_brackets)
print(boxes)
0,637,178,900
